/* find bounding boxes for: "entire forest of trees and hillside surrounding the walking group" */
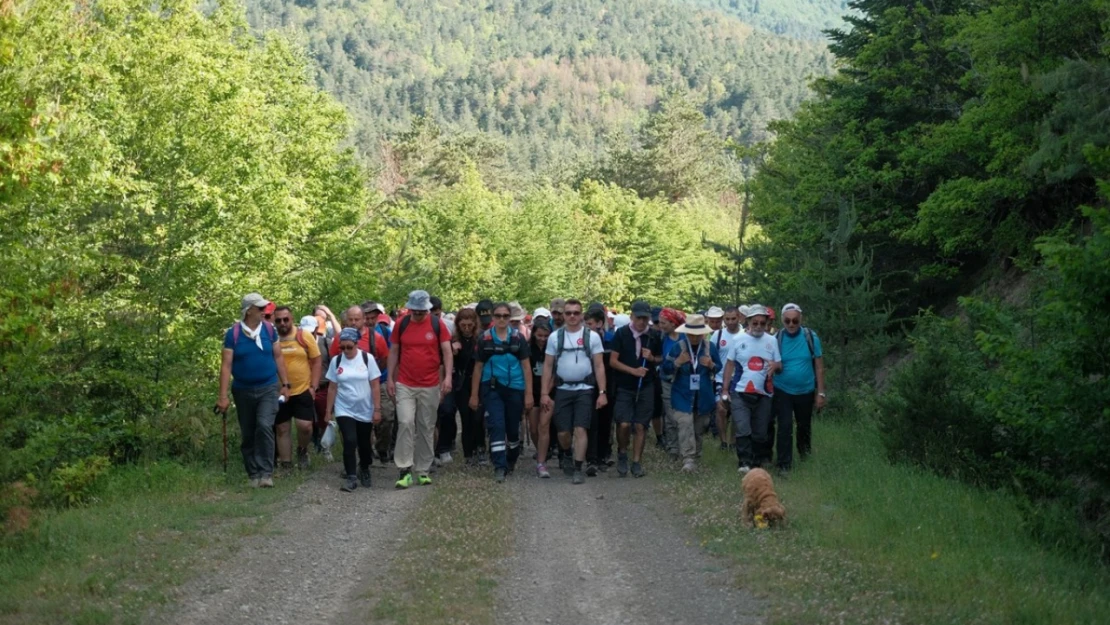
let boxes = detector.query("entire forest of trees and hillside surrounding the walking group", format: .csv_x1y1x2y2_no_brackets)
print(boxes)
0,0,1110,558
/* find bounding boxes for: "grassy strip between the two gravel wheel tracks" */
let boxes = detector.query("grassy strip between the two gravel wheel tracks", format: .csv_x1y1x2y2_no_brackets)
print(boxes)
372,463,512,625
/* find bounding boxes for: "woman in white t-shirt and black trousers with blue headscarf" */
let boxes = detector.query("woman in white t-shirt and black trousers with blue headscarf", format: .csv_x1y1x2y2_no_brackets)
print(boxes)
324,327,382,493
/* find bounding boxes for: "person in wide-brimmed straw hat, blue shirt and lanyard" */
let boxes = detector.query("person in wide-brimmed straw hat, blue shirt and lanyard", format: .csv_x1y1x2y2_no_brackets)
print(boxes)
659,314,717,473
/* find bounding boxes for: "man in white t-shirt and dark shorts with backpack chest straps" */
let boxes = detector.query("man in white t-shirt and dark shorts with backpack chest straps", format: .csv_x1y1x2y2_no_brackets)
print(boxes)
539,300,608,484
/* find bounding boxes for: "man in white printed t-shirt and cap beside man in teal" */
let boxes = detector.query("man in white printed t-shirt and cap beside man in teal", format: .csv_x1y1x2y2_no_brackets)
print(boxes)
720,304,783,473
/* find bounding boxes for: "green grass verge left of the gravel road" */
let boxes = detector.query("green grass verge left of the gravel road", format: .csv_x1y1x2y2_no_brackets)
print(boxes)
0,462,301,625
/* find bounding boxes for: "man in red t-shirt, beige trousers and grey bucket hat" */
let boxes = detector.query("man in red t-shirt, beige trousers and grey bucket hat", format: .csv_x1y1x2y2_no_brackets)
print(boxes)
385,291,454,488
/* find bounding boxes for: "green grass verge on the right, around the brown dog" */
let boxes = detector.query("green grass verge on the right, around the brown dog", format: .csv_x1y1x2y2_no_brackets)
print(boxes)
653,422,1110,624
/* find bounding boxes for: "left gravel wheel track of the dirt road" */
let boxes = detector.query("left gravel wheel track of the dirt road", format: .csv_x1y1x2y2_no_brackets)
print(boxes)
158,464,426,625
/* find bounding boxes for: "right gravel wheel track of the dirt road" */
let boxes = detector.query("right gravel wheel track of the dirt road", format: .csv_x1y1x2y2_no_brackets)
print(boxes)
497,463,763,625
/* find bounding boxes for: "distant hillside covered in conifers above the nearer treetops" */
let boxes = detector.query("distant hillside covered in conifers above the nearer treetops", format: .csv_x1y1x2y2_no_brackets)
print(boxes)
248,0,839,172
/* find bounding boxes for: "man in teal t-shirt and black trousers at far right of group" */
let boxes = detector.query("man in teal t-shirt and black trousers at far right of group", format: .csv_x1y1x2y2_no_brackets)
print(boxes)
773,304,826,471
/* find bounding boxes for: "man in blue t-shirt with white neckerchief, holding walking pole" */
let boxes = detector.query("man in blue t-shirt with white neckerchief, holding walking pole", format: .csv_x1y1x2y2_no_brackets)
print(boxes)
215,293,290,488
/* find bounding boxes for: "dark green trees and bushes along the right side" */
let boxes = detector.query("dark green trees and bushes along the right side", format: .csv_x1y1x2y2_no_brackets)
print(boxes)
741,0,1110,554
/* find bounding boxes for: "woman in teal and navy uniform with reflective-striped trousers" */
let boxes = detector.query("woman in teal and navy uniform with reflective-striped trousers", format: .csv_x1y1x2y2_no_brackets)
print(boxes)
470,303,534,482
